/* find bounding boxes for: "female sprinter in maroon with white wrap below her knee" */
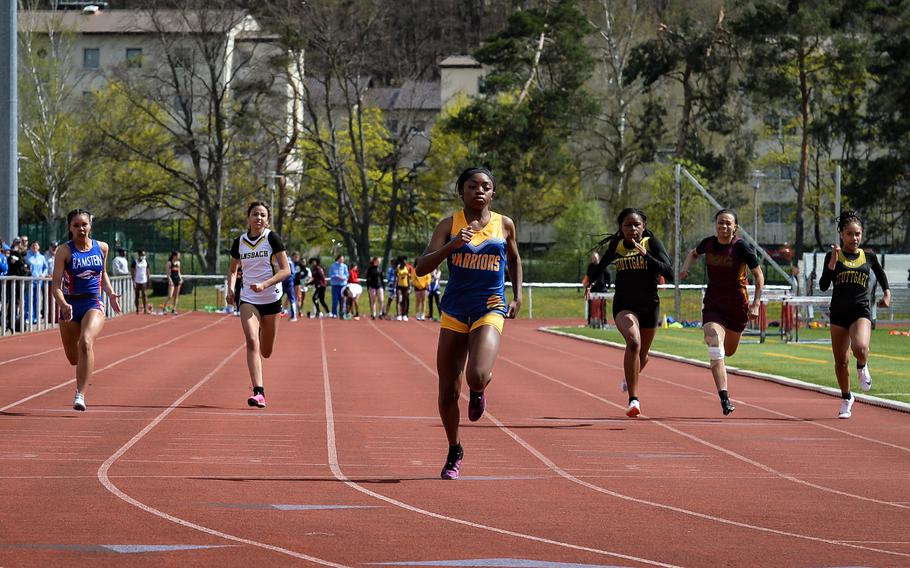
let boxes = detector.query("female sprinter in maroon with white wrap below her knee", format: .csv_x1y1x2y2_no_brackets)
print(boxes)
679,209,765,416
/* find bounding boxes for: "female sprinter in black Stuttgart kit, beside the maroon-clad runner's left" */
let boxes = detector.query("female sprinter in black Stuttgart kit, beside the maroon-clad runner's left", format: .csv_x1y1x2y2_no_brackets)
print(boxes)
595,207,673,418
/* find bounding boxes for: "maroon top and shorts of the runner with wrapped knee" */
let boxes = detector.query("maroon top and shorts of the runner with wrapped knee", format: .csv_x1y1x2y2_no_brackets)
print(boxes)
695,236,758,329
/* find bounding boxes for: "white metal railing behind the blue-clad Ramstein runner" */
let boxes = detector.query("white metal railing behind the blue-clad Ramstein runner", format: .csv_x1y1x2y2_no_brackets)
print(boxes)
0,276,136,336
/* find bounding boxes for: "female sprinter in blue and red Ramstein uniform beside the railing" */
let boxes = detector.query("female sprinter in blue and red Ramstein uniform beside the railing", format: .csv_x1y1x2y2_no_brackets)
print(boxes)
52,209,120,411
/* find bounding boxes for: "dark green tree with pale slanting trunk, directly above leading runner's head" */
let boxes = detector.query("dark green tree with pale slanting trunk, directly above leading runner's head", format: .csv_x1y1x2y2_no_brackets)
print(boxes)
446,0,595,226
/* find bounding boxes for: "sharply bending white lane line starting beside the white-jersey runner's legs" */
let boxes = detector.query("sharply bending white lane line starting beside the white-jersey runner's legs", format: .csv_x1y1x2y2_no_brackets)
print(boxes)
97,344,348,568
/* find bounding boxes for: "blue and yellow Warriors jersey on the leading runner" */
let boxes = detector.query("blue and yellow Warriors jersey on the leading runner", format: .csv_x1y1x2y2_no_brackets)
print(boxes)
441,211,507,316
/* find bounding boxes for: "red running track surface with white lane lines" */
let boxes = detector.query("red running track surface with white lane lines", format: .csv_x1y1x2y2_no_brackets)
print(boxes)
0,314,910,568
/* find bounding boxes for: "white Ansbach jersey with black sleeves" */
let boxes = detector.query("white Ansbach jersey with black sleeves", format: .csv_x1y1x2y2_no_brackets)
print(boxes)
231,229,285,305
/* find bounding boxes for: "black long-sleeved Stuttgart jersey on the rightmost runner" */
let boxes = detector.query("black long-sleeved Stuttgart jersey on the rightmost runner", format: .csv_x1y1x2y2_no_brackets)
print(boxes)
818,249,888,311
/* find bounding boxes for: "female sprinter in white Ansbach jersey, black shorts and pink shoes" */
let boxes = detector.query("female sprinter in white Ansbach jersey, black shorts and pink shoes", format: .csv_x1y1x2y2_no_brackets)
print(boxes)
227,201,291,408
